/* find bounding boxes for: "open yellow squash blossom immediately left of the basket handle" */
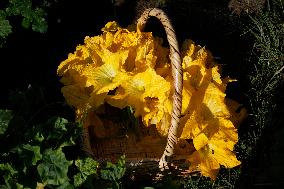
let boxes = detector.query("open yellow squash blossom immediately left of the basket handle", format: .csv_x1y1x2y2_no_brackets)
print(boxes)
107,68,171,125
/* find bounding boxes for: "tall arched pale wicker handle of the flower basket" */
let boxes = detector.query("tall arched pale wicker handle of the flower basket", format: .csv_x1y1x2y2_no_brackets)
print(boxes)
137,8,182,169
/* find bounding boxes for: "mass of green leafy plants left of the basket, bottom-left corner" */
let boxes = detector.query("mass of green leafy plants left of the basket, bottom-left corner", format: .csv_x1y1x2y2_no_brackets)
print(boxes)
0,86,125,189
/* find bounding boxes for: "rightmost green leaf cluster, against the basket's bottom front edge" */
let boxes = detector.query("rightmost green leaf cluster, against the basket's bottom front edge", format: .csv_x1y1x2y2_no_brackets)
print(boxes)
101,155,126,182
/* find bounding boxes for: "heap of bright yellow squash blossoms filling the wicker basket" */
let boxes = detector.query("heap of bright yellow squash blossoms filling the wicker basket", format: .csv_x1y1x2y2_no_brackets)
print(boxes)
58,22,245,179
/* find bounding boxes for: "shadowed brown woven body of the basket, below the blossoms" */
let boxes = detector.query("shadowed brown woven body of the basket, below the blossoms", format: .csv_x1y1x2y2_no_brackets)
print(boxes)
84,105,195,179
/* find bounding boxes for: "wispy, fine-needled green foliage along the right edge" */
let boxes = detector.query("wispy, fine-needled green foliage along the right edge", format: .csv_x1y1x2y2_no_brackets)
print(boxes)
239,0,284,157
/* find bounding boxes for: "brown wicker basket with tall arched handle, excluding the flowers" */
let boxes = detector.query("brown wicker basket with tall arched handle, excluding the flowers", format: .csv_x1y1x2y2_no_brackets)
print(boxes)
80,8,194,179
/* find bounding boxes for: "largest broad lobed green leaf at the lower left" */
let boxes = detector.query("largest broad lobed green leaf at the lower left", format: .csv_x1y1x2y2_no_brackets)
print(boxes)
37,149,72,185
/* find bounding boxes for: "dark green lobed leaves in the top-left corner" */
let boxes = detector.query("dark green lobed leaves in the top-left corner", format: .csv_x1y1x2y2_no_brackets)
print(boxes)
0,0,47,44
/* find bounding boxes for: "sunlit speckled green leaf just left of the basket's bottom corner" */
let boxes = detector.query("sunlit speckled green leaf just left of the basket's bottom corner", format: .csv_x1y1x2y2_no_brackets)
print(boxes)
74,157,99,187
